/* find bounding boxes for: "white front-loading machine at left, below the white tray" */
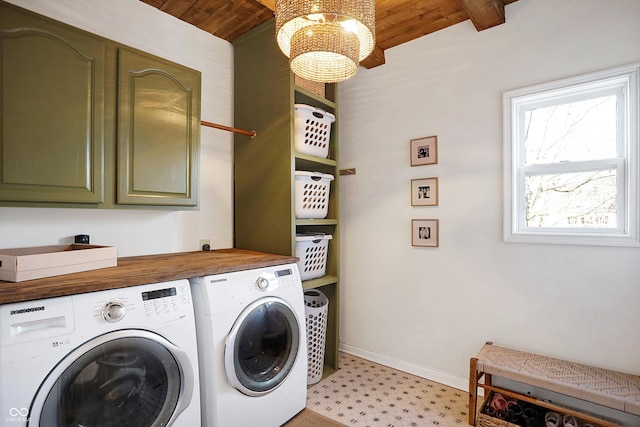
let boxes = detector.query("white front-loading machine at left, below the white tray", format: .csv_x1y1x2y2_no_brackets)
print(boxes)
0,280,200,427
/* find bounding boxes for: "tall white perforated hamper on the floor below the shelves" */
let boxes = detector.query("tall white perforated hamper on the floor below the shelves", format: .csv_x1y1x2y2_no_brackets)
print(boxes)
304,289,329,384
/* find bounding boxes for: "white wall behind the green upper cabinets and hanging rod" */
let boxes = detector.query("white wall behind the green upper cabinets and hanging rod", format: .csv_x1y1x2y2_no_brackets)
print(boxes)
0,0,233,256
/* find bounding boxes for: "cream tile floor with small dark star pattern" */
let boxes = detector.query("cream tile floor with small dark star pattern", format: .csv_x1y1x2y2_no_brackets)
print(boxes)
307,353,469,427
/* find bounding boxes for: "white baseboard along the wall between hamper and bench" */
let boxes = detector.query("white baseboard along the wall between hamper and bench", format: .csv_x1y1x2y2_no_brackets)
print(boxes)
339,343,469,393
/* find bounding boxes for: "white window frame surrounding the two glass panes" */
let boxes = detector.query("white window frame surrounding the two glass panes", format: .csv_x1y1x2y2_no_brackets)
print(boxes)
503,63,640,247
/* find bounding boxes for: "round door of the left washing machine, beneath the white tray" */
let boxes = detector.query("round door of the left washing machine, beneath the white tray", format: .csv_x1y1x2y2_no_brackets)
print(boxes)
28,330,194,427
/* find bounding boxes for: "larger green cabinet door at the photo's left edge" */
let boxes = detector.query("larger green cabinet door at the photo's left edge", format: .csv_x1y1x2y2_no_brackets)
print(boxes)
0,4,105,203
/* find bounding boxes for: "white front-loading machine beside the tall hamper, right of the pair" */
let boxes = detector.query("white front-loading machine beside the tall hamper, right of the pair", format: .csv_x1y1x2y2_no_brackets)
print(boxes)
191,264,307,427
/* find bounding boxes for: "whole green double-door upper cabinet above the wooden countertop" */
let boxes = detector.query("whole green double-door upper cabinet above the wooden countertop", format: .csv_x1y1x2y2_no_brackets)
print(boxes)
0,0,201,209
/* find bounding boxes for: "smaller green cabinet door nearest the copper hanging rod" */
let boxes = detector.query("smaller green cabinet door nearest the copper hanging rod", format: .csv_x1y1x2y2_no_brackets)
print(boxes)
116,49,200,206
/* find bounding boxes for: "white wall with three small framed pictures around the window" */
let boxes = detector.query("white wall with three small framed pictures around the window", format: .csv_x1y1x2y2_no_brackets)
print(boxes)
339,0,640,389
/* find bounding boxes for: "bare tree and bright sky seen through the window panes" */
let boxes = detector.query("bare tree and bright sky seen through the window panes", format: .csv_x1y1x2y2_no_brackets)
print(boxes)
525,96,617,228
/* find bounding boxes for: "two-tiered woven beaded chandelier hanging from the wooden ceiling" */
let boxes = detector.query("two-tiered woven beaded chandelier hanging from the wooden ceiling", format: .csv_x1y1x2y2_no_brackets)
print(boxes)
276,0,376,83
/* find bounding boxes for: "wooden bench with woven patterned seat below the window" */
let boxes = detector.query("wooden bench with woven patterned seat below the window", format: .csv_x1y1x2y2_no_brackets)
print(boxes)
469,342,640,427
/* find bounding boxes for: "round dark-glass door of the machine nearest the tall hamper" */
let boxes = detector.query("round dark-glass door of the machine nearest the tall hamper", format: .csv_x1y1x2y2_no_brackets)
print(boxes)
224,297,300,396
